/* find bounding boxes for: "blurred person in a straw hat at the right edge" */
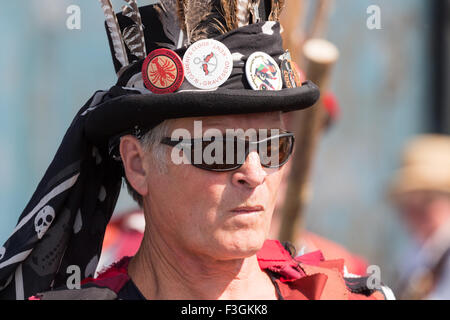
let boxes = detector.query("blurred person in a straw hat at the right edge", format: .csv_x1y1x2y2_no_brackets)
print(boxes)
391,134,450,299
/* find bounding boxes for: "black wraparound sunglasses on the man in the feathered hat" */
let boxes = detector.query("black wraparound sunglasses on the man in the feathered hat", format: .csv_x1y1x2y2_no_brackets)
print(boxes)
161,132,294,172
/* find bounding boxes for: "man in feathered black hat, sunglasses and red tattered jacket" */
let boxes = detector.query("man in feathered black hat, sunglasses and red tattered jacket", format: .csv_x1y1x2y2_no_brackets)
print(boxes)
0,0,383,299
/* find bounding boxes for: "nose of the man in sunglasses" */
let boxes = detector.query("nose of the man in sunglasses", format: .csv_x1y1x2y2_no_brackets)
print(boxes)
232,151,267,189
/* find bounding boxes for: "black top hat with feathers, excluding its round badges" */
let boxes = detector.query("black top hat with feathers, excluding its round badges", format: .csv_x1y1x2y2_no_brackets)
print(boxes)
86,0,319,148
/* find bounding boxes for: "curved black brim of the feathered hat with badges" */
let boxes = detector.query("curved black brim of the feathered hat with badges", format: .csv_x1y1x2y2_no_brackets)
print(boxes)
85,81,320,145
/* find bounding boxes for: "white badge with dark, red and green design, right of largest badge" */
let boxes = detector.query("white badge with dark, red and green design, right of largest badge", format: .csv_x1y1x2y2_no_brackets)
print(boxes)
245,52,283,90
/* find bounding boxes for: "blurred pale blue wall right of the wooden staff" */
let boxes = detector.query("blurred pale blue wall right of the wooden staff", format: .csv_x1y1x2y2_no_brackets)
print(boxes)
307,0,433,282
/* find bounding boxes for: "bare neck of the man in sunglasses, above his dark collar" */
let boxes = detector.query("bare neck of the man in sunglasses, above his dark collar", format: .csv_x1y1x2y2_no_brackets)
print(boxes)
128,233,276,300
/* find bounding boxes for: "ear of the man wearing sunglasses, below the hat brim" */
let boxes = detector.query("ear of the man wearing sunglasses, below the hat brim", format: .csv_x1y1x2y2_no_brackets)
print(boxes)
119,135,148,197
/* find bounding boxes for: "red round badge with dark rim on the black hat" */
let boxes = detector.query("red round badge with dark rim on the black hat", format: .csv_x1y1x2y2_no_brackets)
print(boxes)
142,49,184,94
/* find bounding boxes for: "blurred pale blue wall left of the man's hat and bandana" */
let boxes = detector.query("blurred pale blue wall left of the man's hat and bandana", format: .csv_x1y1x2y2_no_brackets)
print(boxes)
0,0,125,242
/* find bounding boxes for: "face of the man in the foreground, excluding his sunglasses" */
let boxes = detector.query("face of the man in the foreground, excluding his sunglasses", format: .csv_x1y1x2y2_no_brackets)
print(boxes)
144,112,283,260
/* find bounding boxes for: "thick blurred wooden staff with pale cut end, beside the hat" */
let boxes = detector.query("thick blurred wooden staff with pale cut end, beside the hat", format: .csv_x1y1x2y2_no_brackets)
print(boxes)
279,39,339,242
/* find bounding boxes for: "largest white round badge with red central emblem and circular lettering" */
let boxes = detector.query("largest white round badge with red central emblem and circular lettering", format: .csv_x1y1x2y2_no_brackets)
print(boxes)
183,39,233,90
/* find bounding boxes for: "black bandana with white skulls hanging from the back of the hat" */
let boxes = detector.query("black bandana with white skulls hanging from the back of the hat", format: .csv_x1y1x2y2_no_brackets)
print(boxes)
0,87,135,299
